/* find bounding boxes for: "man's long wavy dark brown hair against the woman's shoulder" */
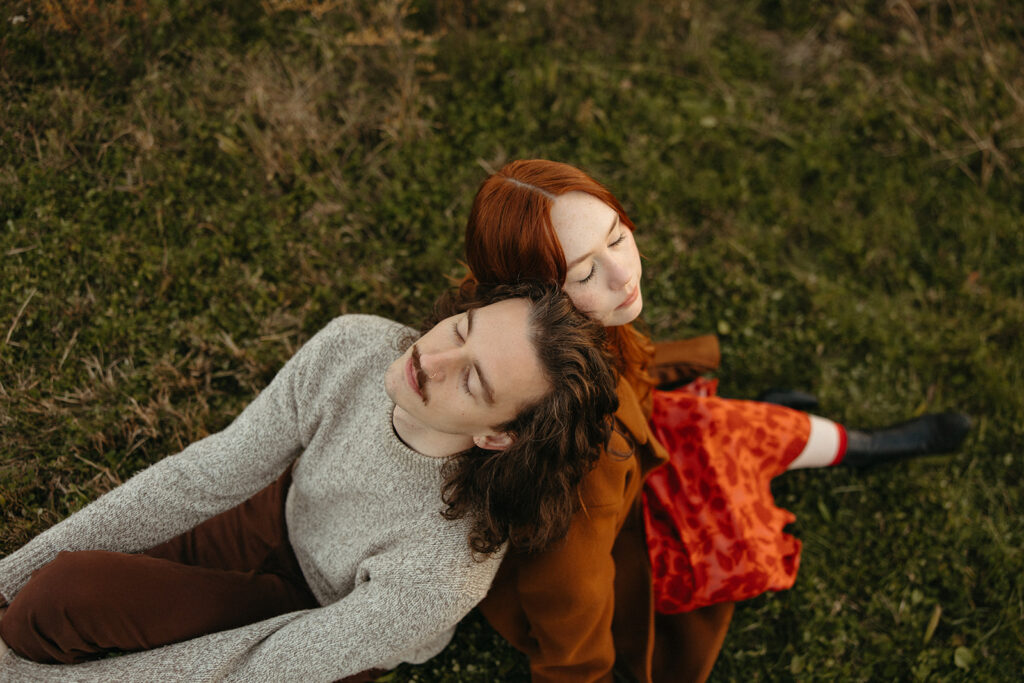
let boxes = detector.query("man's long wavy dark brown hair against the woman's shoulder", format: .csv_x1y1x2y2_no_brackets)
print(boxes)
423,282,618,554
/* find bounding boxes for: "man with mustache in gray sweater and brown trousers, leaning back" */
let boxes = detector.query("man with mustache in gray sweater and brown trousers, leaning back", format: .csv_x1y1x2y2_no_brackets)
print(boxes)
0,285,616,681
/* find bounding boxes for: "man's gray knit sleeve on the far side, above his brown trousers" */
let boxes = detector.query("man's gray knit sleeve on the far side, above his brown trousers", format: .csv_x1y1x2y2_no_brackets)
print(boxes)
0,321,337,600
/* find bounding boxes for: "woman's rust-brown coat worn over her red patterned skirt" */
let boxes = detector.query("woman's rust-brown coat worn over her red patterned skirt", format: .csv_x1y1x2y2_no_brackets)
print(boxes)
480,336,732,683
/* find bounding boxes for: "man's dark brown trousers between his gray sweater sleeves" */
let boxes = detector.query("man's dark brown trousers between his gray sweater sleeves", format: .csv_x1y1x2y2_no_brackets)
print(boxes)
0,470,383,683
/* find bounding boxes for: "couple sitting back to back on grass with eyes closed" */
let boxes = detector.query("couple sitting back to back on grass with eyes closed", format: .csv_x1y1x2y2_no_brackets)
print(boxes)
0,160,967,681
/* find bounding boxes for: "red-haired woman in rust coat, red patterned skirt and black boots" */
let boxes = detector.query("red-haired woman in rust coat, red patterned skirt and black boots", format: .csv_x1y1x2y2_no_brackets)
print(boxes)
465,160,968,681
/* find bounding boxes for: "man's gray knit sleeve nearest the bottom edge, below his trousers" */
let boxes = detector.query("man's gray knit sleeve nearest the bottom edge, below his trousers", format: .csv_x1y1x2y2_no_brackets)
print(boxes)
0,525,500,683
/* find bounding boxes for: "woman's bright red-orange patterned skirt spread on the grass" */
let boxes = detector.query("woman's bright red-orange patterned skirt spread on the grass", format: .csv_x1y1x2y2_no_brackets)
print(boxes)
643,378,810,613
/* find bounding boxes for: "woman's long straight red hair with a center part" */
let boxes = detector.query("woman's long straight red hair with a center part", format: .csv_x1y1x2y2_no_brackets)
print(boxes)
463,159,653,397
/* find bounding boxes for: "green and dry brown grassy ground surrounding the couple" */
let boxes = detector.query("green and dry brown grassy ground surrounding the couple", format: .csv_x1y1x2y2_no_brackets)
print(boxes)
0,0,1024,682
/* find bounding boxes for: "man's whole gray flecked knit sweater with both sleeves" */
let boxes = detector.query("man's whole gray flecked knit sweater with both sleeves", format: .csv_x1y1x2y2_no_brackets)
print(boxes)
0,315,500,682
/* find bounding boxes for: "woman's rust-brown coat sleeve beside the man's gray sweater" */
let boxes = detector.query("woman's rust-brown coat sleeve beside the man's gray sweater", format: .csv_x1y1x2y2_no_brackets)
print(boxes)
481,440,639,683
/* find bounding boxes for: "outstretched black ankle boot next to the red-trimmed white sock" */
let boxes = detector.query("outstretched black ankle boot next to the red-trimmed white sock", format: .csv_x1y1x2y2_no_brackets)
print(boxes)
840,413,971,467
